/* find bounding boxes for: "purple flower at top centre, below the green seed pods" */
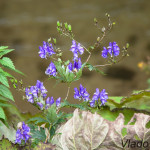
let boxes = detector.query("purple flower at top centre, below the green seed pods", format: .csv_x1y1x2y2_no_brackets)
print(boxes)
70,40,84,61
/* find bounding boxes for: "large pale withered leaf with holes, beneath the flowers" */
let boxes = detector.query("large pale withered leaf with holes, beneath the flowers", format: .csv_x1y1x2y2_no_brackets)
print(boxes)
52,109,150,150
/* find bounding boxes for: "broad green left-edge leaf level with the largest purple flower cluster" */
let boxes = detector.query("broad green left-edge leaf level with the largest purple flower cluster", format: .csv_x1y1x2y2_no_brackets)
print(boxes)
0,85,14,101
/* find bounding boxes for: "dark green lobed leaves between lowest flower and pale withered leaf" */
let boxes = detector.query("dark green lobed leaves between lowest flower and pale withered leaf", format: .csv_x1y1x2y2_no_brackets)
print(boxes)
27,105,71,147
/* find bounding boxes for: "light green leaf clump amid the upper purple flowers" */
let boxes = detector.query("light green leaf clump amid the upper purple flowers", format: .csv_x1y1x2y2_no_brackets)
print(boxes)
53,60,83,83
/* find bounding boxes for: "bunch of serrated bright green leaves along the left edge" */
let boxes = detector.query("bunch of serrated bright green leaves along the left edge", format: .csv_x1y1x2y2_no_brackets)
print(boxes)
0,46,23,126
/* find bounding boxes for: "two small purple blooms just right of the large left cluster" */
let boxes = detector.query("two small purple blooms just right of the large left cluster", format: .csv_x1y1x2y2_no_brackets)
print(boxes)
45,96,61,109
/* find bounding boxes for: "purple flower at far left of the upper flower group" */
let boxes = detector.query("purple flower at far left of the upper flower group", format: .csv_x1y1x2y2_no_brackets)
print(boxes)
39,41,55,58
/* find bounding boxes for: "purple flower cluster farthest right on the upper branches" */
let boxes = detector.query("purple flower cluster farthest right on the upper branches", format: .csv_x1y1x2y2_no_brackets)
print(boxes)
102,42,120,58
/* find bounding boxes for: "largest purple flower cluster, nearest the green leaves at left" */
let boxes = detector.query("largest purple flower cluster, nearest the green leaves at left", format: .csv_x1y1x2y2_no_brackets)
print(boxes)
25,80,47,106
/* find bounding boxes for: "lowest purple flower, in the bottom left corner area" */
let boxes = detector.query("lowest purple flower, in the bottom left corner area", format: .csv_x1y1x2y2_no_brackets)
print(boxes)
15,122,31,144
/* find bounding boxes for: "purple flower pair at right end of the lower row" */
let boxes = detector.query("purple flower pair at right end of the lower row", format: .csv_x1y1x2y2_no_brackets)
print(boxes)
90,88,108,107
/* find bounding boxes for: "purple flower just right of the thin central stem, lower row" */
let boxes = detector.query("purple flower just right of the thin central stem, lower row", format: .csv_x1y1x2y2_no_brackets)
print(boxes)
74,84,90,101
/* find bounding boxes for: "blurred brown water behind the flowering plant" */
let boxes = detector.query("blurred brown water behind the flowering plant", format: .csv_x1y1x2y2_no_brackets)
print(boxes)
0,0,150,112
